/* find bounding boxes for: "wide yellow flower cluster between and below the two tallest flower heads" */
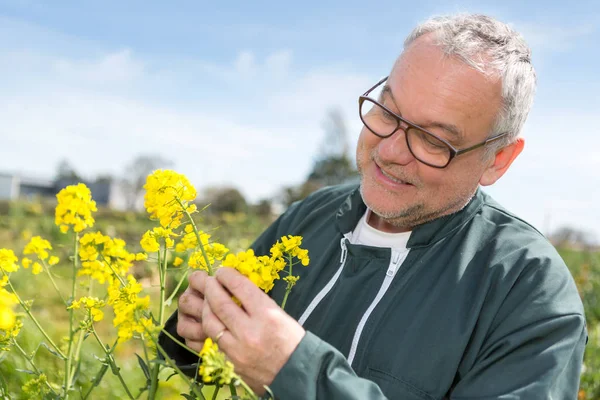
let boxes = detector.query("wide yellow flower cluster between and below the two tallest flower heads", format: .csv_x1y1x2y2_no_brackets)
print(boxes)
77,232,147,284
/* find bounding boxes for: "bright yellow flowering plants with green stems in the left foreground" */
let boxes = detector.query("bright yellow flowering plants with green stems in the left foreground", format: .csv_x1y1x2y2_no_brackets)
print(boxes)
0,170,309,399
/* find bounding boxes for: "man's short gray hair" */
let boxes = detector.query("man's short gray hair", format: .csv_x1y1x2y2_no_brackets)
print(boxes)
404,14,536,156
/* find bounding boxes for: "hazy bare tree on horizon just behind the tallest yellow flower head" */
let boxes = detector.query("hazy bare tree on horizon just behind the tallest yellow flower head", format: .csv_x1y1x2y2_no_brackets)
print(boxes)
122,154,173,210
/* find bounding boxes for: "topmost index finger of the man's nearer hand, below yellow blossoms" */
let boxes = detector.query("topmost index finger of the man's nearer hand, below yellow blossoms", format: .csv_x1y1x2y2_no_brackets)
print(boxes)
215,268,273,315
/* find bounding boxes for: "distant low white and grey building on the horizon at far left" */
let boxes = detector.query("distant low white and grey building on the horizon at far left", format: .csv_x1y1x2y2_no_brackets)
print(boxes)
0,172,127,210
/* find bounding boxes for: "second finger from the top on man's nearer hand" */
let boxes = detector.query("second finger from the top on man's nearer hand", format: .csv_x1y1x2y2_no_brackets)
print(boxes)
202,276,249,337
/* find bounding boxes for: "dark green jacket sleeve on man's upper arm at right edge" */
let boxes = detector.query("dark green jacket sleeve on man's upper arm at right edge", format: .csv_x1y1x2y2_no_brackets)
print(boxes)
450,248,587,400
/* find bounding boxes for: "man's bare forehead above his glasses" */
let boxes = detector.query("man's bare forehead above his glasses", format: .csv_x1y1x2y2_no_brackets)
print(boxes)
386,36,502,140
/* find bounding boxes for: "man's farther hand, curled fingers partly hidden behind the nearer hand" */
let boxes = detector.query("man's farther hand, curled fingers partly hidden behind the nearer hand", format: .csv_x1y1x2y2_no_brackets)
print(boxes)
177,271,208,352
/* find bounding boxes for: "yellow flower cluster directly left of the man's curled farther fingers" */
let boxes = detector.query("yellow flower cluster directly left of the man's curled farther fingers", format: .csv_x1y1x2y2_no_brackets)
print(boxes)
108,275,152,342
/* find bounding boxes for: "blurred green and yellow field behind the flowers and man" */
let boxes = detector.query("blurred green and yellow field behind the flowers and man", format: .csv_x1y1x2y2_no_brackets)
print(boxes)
0,202,600,399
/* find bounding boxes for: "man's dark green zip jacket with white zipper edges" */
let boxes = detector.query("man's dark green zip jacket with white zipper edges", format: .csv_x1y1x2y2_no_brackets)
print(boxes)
162,185,587,400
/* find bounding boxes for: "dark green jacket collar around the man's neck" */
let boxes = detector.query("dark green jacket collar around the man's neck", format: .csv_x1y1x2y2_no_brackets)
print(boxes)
336,186,485,248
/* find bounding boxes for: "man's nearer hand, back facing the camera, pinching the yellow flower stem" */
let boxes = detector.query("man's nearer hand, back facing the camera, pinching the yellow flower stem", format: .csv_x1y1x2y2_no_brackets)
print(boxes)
202,268,305,395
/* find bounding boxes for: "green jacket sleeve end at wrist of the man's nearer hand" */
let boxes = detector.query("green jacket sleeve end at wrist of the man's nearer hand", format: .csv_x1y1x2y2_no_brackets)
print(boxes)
269,332,387,400
